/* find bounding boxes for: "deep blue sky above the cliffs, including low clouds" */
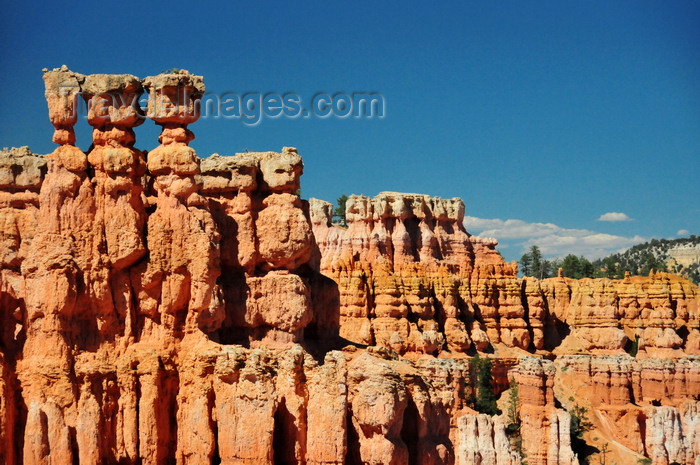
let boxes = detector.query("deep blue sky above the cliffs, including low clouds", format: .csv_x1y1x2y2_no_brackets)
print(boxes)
0,0,700,260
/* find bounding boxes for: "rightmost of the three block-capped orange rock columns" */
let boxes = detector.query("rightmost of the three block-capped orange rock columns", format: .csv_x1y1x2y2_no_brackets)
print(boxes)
140,71,224,333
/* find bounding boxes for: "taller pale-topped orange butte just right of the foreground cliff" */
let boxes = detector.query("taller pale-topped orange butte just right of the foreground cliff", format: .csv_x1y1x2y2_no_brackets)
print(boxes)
311,192,516,354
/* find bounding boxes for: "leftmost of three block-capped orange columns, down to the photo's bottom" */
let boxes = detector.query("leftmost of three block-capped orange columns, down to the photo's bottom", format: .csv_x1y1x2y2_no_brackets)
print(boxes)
17,66,94,464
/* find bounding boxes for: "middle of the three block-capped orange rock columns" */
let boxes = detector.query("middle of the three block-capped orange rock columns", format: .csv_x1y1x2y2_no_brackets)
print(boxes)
82,74,146,337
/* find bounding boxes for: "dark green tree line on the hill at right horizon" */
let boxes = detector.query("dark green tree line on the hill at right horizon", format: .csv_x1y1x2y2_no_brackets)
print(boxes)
518,235,700,284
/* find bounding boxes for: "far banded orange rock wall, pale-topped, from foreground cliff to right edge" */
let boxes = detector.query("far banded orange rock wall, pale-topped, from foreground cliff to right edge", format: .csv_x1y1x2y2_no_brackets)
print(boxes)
311,192,700,358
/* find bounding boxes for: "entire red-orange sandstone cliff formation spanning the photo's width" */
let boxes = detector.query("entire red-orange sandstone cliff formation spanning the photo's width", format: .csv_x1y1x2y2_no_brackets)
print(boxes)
0,68,700,465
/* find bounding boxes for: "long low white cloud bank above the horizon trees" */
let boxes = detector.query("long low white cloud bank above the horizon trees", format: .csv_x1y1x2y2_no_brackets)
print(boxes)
464,216,646,259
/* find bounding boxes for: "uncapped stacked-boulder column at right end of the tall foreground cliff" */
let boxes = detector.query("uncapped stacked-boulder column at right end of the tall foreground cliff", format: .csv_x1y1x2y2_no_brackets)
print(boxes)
245,147,313,344
